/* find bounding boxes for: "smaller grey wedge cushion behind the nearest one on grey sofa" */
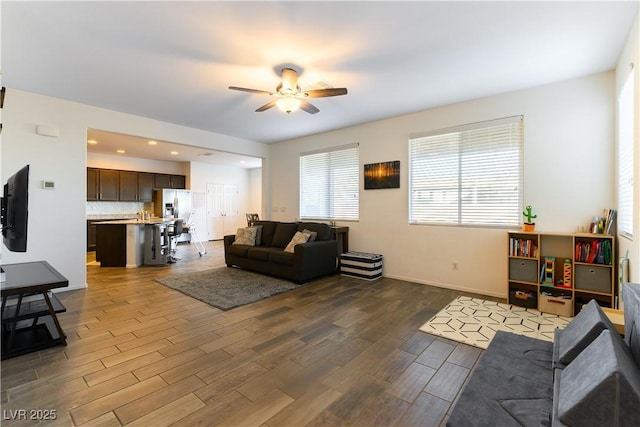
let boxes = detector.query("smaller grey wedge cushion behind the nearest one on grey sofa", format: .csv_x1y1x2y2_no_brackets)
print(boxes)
554,300,616,365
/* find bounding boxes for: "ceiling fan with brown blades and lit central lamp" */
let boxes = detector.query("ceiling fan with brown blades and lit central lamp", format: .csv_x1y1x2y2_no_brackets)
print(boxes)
229,68,347,114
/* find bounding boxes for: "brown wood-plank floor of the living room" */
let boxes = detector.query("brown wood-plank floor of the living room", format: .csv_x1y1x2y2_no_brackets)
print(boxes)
1,242,496,427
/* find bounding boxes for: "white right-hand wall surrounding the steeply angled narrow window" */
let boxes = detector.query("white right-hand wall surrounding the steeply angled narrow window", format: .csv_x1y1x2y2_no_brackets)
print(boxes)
616,13,640,283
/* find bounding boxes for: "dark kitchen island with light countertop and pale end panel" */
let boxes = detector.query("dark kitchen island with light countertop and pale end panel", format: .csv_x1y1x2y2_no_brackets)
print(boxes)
94,218,174,268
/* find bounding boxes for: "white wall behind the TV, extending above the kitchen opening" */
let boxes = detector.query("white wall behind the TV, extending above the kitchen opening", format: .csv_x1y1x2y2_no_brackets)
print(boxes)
0,88,269,288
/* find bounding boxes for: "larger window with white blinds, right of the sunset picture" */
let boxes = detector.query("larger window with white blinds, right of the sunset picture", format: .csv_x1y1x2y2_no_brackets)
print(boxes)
409,116,523,227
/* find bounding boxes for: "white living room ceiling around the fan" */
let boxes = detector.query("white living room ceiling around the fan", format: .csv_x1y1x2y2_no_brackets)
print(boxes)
1,0,638,164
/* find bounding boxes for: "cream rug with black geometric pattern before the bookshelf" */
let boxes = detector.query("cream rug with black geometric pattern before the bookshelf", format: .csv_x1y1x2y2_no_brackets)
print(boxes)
420,296,572,349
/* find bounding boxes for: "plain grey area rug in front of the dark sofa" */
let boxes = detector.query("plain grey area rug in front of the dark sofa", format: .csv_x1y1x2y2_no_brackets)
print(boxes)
156,267,302,310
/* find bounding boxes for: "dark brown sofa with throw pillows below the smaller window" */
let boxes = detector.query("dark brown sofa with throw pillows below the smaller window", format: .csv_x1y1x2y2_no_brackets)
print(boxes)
224,221,338,283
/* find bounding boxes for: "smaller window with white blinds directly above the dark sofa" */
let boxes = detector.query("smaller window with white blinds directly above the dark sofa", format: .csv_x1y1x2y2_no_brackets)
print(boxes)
300,144,360,220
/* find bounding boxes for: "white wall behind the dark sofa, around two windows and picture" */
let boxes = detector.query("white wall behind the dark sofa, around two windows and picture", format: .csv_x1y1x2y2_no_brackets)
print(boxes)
268,72,614,297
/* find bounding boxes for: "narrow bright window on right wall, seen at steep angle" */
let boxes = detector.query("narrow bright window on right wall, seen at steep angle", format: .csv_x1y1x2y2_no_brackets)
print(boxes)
618,72,635,238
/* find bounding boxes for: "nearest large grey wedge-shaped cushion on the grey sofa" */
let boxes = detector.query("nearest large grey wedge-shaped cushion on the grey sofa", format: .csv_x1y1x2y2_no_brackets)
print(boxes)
554,329,640,426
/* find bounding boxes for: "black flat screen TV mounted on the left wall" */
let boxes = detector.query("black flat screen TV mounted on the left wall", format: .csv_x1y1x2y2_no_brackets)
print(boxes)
0,165,29,252
